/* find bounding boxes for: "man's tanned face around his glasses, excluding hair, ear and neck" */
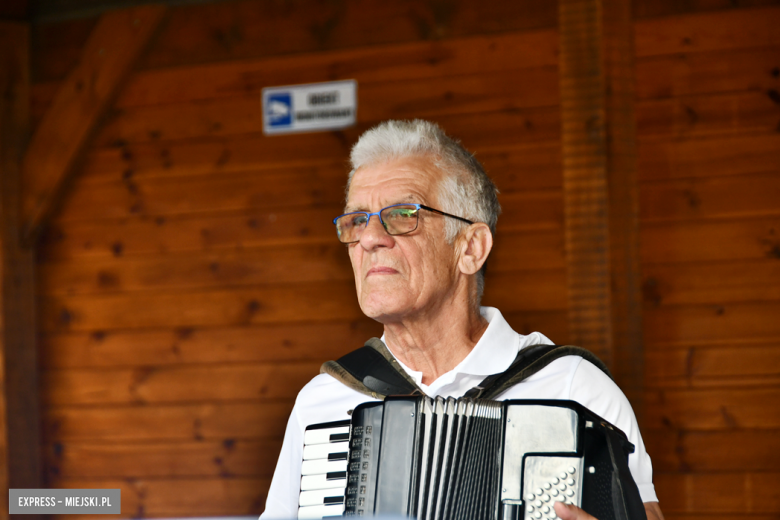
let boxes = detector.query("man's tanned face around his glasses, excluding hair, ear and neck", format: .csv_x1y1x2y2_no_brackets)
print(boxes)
345,158,458,323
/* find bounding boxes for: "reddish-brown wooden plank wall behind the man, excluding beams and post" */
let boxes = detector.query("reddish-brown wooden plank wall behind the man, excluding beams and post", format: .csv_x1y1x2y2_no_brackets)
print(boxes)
24,0,780,520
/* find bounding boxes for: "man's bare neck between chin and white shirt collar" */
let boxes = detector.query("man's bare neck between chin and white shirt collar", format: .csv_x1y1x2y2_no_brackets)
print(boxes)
384,309,488,385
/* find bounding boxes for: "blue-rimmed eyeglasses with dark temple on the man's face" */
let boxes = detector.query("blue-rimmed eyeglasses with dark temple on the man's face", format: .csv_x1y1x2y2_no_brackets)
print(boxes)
333,204,473,244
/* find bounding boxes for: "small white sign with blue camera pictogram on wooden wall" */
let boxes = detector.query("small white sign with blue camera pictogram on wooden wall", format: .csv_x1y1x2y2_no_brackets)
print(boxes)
263,80,357,135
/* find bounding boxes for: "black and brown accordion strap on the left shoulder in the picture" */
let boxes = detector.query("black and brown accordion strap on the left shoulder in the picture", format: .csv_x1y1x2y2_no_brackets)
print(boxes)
320,338,423,399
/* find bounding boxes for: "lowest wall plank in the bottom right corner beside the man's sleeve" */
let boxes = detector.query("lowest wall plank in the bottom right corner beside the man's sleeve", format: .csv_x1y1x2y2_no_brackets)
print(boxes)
653,472,780,518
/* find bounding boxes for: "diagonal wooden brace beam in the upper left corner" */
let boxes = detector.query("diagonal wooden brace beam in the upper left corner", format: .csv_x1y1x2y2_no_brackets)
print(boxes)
22,5,165,240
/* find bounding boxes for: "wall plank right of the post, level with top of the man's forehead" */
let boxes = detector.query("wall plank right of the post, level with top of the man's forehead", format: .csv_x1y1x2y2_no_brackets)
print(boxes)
639,132,780,181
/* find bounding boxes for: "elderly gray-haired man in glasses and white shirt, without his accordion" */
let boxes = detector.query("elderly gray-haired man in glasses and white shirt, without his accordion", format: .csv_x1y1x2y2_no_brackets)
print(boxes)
261,121,663,520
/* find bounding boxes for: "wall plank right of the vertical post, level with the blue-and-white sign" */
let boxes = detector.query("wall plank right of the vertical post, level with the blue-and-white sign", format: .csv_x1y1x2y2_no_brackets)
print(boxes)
636,91,780,139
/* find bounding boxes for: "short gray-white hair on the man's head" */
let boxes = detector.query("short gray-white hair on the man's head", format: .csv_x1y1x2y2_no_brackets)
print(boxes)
347,119,501,300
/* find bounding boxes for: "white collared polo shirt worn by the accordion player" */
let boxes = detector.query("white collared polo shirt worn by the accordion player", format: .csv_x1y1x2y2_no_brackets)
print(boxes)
260,307,658,519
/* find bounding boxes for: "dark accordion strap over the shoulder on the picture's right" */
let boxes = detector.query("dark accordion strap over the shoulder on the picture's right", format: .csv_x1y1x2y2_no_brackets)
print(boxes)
464,345,613,399
